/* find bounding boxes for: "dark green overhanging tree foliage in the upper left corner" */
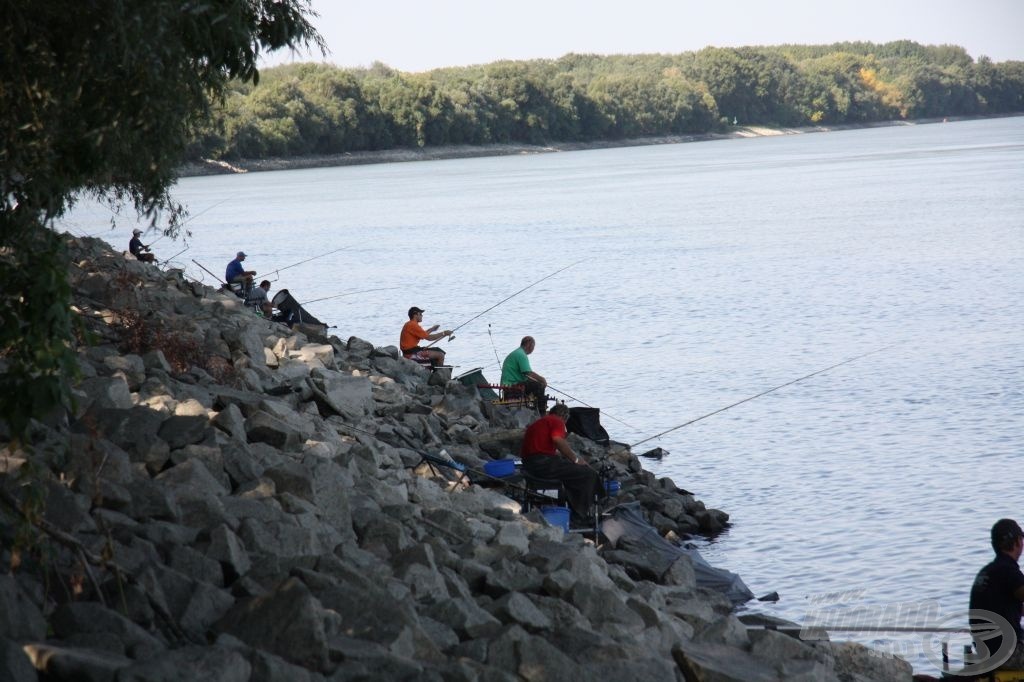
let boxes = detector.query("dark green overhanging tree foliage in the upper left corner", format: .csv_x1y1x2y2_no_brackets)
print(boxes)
0,0,322,439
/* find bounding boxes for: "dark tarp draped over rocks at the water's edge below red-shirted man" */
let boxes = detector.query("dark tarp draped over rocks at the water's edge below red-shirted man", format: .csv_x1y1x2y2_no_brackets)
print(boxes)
601,502,754,605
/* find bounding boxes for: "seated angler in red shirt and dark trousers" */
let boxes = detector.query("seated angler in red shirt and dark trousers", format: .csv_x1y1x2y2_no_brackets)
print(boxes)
519,402,600,519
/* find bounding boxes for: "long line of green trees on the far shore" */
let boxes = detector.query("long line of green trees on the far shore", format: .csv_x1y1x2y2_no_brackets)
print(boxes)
189,41,1024,159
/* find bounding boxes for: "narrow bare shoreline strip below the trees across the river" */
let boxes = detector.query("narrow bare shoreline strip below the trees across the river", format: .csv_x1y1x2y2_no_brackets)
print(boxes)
179,115,1019,177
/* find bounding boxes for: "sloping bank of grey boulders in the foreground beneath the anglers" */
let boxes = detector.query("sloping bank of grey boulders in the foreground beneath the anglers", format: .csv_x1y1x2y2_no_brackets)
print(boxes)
0,232,910,682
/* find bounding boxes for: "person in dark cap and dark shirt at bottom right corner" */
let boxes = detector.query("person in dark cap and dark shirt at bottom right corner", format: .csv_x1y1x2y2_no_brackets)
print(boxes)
970,518,1024,670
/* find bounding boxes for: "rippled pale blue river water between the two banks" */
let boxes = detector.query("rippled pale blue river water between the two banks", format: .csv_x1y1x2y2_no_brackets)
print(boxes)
62,118,1024,672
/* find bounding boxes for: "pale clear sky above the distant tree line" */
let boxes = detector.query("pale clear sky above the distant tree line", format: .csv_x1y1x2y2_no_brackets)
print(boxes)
261,0,1024,72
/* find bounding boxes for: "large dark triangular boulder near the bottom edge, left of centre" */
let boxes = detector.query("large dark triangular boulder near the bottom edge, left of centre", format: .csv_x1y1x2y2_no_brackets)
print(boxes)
216,578,330,672
